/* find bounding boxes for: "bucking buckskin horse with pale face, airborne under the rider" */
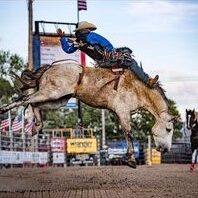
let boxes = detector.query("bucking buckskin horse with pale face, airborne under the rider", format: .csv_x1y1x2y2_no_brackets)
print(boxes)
0,62,173,168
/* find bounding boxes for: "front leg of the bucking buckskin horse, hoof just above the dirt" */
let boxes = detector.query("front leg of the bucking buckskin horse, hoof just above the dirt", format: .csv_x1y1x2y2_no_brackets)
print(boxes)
117,112,137,168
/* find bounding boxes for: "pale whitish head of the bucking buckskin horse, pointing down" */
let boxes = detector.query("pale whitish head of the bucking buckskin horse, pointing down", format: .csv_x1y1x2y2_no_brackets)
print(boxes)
152,114,175,152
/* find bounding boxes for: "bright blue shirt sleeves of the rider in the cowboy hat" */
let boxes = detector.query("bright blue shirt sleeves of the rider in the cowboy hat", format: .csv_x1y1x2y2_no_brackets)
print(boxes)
60,32,114,54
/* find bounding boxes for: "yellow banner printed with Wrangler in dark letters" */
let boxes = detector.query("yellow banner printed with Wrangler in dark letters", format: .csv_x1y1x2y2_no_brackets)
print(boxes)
67,138,97,154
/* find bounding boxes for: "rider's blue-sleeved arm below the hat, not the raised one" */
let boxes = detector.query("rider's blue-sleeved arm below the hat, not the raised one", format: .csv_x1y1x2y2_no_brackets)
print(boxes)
87,32,114,52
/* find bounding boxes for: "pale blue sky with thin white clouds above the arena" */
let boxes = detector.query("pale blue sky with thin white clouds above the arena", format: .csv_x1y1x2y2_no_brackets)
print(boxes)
0,0,198,120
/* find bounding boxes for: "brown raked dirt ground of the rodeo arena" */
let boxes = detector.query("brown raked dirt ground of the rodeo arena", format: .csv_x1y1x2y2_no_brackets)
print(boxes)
0,164,198,198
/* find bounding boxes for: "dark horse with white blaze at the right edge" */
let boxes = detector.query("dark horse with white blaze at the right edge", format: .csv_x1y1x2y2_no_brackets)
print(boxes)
186,109,198,171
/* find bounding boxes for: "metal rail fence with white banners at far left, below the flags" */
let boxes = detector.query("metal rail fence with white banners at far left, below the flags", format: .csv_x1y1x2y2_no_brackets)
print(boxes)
0,131,50,167
